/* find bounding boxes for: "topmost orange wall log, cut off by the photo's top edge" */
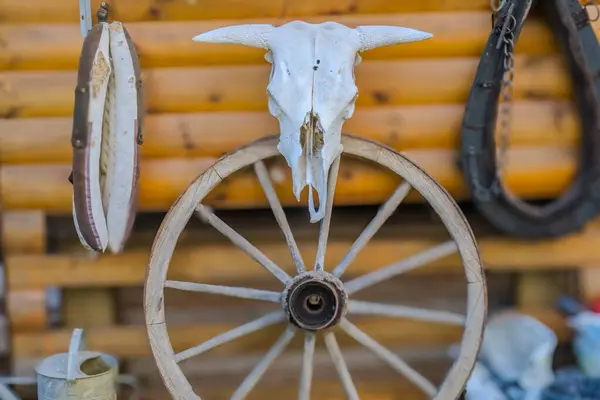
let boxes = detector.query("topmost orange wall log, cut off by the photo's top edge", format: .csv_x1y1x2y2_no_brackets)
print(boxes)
0,0,490,23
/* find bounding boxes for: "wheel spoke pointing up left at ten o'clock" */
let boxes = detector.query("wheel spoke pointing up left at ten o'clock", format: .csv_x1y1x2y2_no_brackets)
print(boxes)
196,204,292,284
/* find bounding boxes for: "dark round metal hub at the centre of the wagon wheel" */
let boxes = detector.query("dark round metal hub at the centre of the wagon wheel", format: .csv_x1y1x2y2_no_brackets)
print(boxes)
282,271,347,331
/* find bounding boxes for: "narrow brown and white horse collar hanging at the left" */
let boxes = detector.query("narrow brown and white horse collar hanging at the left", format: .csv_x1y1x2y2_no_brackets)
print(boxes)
69,3,144,253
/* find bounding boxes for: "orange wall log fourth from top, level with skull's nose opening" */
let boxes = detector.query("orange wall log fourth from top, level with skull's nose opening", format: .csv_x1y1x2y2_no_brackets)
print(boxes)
0,100,579,164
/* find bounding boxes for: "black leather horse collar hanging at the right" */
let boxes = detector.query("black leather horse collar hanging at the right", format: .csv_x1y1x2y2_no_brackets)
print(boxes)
460,0,600,239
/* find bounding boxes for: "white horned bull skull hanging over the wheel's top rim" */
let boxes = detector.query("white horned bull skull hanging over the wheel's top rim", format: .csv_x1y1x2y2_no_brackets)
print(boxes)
193,21,432,222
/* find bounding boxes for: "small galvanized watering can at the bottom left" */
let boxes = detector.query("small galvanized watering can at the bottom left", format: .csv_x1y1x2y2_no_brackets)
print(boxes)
35,329,119,400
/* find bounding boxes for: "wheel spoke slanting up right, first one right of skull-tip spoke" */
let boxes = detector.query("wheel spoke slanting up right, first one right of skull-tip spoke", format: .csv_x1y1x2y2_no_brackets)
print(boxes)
332,181,412,278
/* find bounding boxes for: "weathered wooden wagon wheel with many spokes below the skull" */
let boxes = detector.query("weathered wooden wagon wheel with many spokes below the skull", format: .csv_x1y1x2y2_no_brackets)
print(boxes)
144,135,487,400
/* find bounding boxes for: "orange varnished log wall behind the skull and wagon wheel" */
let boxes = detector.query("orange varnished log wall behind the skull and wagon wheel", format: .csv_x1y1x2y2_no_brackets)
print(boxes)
0,0,600,399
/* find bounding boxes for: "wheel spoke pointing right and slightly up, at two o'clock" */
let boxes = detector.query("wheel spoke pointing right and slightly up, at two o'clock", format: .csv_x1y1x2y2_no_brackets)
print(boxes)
344,240,458,294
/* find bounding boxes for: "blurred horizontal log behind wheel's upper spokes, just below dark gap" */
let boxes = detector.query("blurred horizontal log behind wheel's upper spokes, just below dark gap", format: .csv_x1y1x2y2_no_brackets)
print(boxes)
6,230,600,290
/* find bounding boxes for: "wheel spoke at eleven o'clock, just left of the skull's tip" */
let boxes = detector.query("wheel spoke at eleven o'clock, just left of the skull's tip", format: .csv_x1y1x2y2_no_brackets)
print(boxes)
254,161,306,274
